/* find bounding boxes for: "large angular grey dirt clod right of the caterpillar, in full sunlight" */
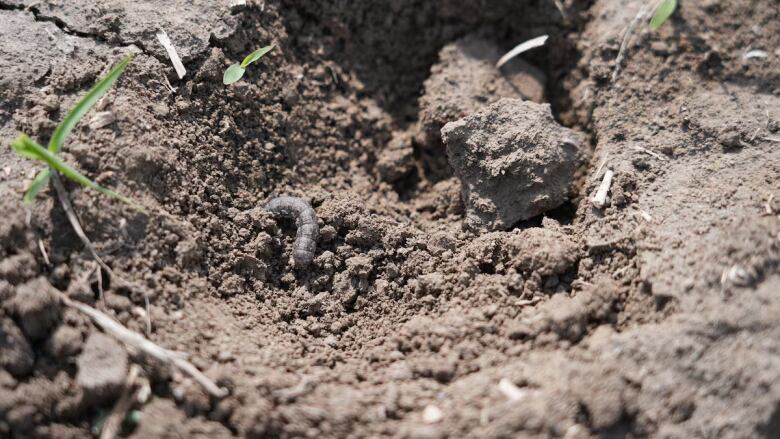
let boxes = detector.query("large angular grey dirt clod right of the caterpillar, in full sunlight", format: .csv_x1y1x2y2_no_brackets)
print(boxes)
441,99,584,230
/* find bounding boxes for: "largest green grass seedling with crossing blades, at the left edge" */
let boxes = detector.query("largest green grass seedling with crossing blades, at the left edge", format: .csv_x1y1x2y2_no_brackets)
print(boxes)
11,54,142,210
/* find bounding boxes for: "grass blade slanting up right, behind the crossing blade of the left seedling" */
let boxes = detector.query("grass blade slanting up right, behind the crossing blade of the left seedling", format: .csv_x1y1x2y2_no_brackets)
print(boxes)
24,54,133,206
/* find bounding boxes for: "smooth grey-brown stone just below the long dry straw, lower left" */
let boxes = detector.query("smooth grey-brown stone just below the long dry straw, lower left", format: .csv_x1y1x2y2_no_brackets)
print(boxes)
76,332,128,403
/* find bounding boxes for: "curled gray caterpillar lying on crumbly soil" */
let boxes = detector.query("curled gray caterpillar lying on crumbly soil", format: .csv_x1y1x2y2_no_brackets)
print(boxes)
265,197,320,267
